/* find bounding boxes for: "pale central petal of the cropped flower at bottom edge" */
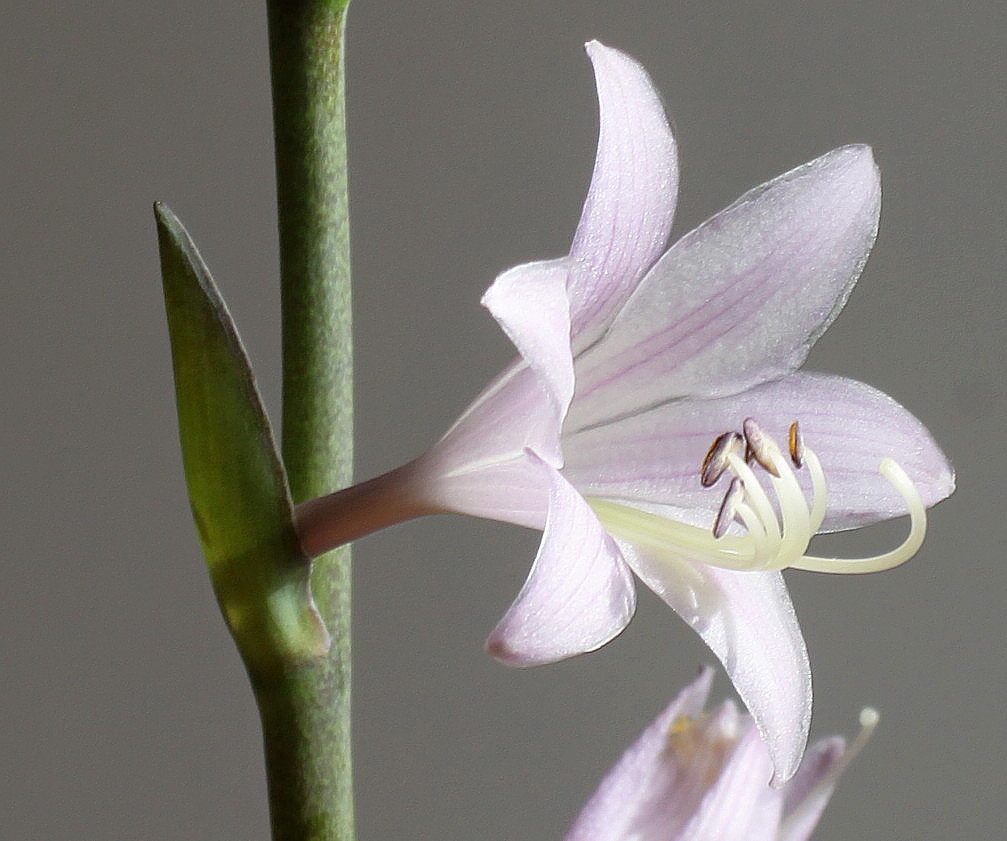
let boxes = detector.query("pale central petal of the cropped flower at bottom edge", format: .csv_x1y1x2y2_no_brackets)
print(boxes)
677,720,782,841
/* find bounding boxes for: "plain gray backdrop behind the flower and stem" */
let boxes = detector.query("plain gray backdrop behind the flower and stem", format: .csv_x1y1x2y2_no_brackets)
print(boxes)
0,0,1007,841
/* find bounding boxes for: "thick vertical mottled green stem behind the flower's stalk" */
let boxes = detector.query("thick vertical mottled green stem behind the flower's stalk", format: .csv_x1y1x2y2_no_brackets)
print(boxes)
252,0,353,841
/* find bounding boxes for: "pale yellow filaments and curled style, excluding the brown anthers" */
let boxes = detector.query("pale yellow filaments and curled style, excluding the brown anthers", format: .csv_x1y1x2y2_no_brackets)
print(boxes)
588,431,926,573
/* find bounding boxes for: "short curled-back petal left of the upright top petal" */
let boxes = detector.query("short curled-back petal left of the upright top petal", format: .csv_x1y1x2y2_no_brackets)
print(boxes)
482,260,574,421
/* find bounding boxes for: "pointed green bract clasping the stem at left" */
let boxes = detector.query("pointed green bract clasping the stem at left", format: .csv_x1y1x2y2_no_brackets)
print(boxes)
154,204,329,671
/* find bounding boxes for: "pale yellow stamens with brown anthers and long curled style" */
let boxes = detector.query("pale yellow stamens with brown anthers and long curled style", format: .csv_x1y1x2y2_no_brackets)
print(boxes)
588,418,926,573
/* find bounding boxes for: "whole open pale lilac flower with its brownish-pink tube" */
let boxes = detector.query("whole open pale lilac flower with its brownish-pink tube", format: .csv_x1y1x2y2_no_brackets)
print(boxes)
300,42,953,780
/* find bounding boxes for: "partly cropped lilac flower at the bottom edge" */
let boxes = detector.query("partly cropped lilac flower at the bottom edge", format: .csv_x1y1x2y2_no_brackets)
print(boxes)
566,670,877,841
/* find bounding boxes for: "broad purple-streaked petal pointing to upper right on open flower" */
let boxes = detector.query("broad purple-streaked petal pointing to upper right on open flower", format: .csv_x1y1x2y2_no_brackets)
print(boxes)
567,146,881,431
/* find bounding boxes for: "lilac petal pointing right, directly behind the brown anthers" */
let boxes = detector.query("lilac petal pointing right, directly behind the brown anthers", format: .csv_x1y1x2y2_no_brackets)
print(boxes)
564,373,955,531
